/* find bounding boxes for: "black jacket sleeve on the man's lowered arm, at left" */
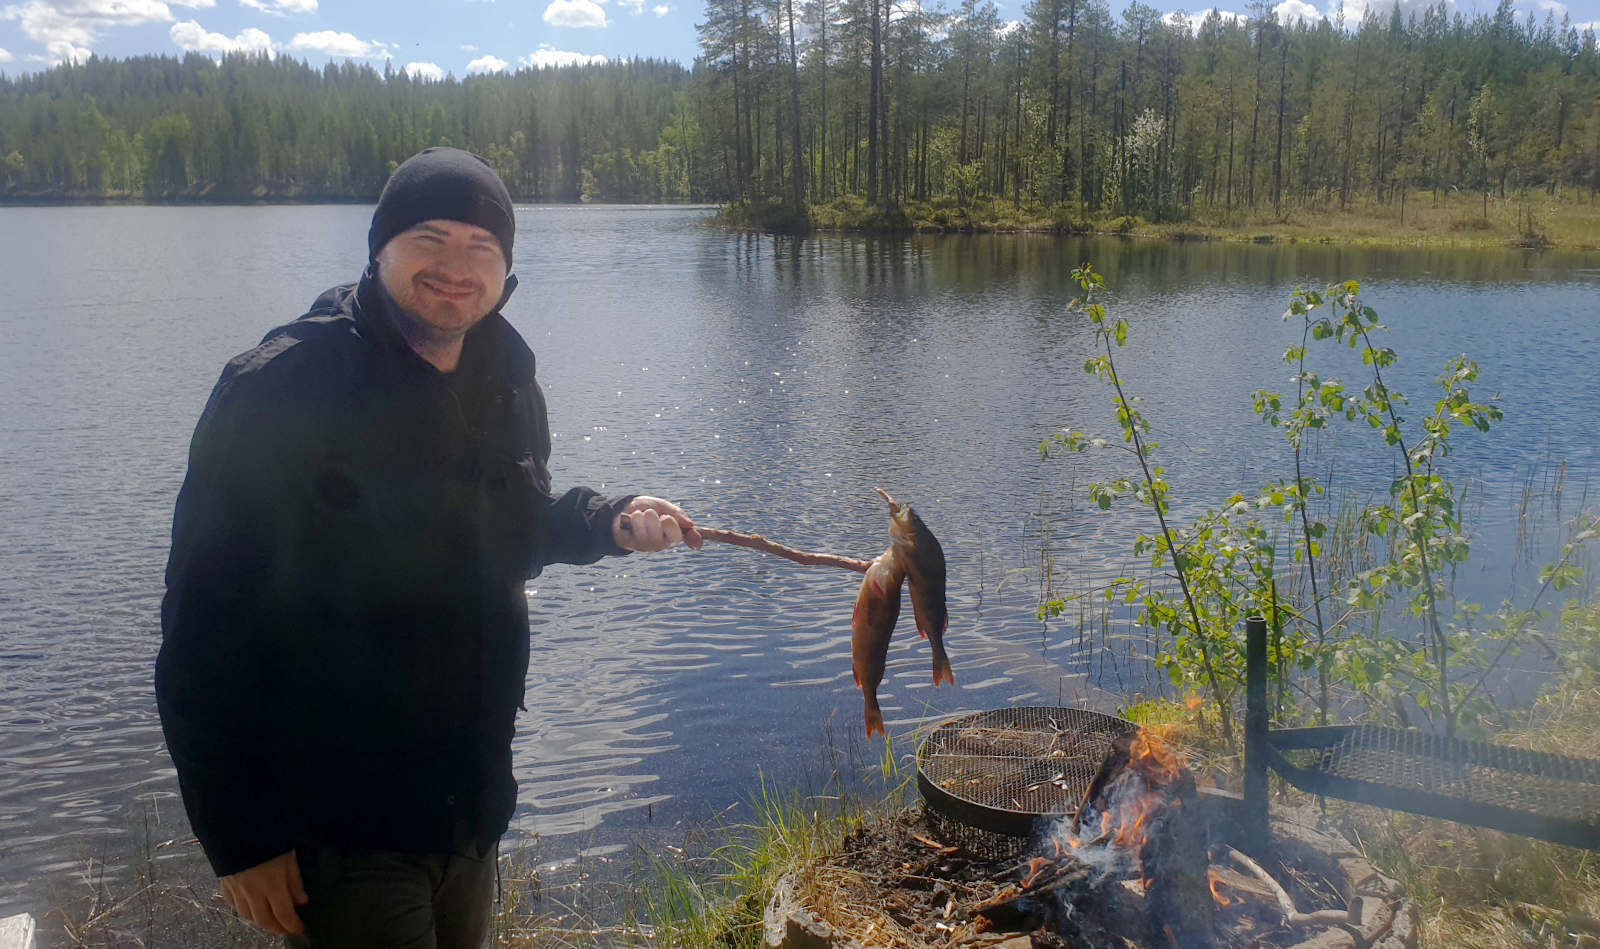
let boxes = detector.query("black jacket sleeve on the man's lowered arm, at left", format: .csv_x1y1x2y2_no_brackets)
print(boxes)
155,366,294,877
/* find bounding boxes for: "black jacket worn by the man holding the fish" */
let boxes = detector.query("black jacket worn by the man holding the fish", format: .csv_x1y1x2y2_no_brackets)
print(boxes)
155,274,627,875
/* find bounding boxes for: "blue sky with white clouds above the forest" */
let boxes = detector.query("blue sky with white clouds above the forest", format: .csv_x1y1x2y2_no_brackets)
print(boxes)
0,0,1600,78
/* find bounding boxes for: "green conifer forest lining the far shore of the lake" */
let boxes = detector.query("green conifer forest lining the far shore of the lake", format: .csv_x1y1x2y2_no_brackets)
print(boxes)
0,0,1600,219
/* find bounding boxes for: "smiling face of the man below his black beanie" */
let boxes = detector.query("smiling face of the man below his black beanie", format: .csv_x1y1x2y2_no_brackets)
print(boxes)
378,219,506,339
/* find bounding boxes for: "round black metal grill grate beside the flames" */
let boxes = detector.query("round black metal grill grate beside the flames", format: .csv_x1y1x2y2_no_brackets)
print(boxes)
917,706,1138,837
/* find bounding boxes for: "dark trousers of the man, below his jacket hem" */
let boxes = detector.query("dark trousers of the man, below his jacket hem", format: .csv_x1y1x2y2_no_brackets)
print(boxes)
286,843,498,949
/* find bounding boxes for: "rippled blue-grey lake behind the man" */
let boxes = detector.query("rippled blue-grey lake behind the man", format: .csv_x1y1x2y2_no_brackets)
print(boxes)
0,206,1600,915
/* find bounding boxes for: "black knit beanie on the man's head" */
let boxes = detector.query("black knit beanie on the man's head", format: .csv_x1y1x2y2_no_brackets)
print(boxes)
366,147,517,270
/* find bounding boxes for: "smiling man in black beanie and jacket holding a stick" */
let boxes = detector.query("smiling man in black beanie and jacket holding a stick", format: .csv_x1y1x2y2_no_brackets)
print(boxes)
155,149,701,949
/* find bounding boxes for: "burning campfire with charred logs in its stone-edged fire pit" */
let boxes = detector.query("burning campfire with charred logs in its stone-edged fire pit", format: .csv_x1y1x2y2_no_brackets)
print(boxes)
768,725,1414,949
